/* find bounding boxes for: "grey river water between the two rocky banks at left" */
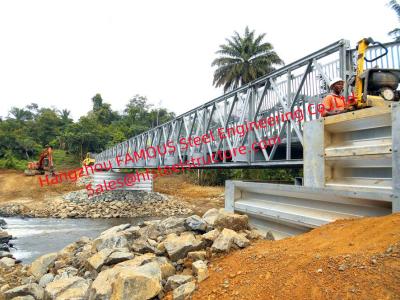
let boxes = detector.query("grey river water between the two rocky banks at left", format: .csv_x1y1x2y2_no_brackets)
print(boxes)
3,218,159,264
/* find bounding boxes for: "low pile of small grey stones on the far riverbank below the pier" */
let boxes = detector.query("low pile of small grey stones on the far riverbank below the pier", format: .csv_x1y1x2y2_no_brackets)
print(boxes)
0,190,192,218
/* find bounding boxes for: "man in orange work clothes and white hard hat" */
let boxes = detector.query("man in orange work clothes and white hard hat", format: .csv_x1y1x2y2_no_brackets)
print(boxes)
322,77,353,117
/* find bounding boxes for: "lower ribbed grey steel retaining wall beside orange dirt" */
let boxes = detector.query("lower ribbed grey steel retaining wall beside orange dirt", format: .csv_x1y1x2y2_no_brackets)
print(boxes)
225,180,392,239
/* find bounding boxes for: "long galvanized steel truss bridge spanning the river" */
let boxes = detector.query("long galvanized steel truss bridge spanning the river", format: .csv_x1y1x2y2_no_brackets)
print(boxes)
95,40,400,169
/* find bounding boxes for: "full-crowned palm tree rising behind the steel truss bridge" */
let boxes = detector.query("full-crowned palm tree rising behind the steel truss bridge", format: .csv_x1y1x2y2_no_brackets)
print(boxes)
211,26,283,92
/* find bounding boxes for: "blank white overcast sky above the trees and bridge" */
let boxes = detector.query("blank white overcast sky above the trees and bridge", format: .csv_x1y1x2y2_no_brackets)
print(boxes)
0,0,399,120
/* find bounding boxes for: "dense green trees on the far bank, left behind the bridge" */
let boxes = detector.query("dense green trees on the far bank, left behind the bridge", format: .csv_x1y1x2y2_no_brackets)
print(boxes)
0,94,174,169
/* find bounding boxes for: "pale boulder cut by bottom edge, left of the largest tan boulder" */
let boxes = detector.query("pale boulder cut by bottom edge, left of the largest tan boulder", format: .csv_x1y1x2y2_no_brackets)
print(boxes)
44,276,90,300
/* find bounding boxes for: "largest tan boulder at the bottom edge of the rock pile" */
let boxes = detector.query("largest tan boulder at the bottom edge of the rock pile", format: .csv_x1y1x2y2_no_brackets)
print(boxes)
111,262,162,300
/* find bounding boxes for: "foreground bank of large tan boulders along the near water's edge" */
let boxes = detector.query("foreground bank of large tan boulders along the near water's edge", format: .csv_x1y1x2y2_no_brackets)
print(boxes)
0,209,272,300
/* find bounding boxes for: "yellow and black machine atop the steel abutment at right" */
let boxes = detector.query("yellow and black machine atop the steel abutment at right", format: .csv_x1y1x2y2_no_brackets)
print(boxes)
354,38,400,108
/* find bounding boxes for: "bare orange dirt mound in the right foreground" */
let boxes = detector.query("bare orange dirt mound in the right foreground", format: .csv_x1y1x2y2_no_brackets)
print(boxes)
193,214,400,300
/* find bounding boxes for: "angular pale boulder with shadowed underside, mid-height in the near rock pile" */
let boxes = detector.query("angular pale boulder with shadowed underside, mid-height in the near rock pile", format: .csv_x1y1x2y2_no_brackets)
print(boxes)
164,232,204,261
